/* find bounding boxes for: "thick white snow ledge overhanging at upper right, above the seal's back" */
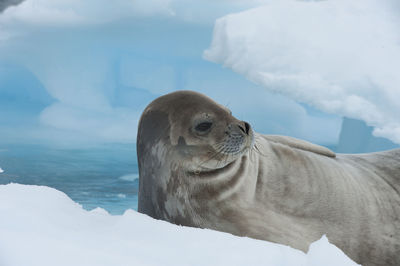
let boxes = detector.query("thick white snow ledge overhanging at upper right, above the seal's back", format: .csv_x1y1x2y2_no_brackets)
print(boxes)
204,0,400,143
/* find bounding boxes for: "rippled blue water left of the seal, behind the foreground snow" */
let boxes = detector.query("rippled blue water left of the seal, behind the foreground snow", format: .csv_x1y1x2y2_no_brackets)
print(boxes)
0,144,138,214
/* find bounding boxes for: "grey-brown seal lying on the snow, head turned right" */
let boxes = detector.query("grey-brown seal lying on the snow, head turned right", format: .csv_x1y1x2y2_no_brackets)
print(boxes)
137,91,400,265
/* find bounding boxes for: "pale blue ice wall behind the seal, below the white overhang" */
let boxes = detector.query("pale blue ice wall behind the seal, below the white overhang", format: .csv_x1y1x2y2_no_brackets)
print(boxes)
0,0,341,146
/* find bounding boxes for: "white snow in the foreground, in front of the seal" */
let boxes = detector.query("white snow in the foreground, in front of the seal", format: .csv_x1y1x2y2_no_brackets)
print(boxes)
0,184,356,266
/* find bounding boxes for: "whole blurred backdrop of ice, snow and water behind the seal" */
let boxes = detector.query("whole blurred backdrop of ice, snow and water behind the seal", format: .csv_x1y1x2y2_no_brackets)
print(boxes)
0,0,400,214
